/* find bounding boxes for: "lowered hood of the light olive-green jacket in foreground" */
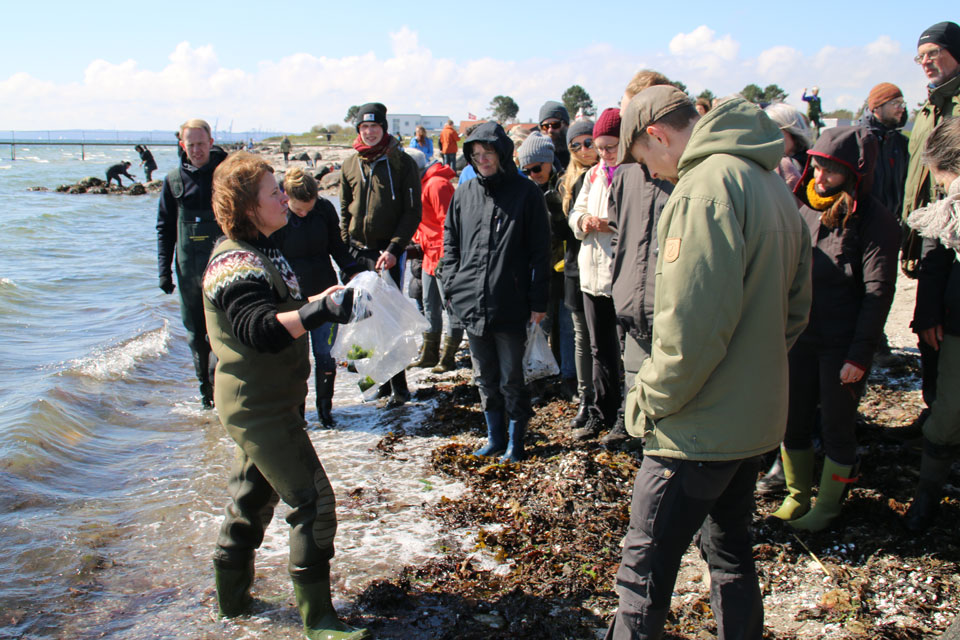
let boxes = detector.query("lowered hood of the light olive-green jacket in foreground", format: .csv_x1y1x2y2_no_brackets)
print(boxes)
677,98,783,178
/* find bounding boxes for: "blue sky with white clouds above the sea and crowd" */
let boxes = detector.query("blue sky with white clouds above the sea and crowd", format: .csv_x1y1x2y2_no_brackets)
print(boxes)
0,0,958,133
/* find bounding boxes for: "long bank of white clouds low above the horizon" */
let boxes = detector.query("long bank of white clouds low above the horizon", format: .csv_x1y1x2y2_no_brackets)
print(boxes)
0,25,924,131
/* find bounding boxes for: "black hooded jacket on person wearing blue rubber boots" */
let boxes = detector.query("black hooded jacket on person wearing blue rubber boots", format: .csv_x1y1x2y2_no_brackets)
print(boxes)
440,122,551,335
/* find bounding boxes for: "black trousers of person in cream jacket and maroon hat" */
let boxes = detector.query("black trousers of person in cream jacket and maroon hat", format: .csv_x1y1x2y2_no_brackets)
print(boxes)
583,293,623,427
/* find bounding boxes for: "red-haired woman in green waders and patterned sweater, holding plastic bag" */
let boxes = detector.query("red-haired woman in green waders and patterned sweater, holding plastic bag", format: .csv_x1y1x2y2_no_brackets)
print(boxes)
203,151,368,640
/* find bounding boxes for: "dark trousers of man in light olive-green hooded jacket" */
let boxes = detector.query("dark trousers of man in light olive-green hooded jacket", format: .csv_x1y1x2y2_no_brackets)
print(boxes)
606,456,763,640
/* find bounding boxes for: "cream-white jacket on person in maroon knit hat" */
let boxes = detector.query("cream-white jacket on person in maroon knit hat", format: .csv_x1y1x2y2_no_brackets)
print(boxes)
567,162,613,297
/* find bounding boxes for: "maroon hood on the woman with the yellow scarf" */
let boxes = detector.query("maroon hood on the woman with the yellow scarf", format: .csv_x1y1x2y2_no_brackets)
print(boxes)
793,126,880,200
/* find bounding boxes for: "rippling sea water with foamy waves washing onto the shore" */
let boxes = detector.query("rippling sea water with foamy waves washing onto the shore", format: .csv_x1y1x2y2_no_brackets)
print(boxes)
0,145,462,639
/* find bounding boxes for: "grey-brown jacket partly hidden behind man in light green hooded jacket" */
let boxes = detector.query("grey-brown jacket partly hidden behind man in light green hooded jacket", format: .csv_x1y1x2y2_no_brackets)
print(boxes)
608,163,673,342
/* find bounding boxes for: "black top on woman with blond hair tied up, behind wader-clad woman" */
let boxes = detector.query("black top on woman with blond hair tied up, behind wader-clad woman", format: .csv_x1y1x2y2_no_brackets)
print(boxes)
270,196,363,298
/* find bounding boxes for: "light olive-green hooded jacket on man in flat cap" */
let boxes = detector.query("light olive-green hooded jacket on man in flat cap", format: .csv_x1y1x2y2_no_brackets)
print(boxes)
626,98,811,460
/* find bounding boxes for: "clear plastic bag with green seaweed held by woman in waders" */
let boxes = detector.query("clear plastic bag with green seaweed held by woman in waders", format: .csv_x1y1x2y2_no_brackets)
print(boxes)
330,271,429,400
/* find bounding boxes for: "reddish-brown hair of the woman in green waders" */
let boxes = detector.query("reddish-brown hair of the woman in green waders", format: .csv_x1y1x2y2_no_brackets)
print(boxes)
213,151,273,240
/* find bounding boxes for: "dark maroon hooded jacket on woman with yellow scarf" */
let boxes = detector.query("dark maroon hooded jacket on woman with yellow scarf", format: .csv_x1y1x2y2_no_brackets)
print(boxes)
795,127,900,369
